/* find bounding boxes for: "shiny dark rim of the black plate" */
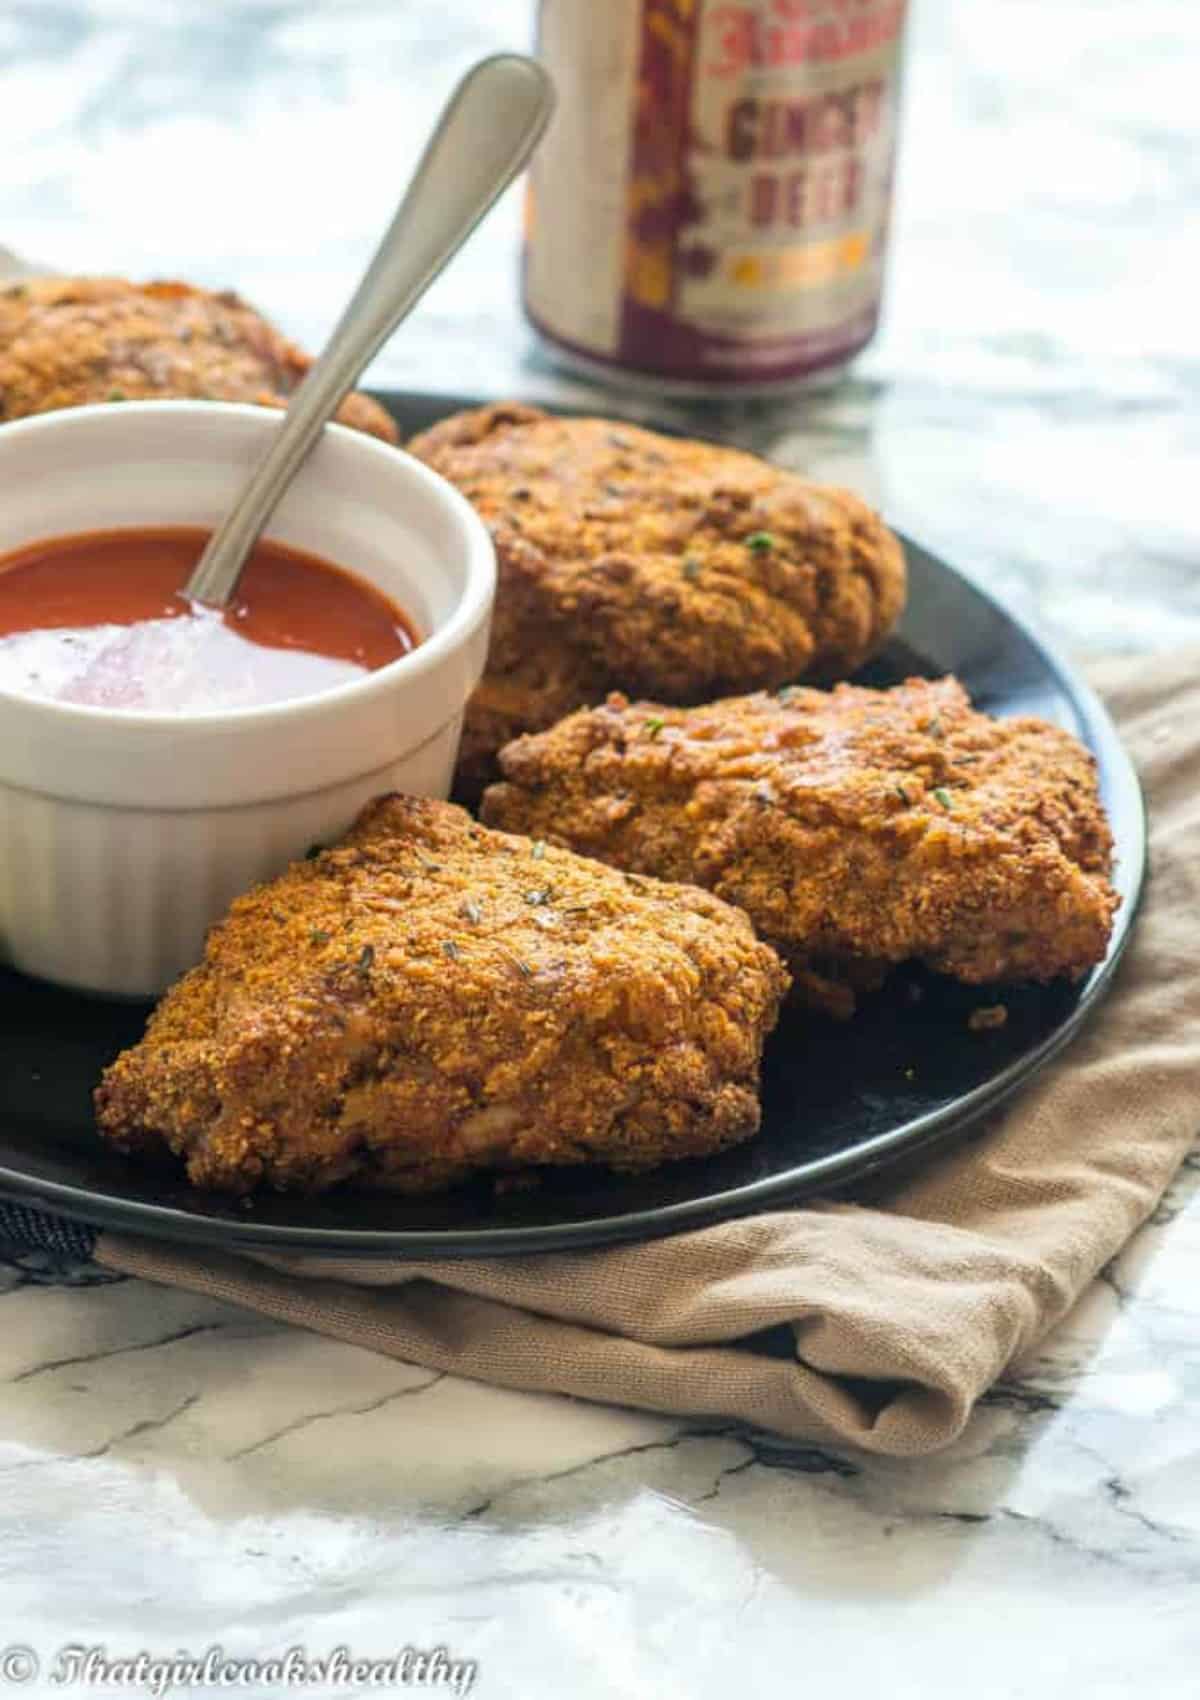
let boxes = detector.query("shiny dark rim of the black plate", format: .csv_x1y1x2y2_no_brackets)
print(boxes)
0,394,1146,1258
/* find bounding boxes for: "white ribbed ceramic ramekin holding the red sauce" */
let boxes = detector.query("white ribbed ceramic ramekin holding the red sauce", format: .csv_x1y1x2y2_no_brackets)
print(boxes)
0,401,496,996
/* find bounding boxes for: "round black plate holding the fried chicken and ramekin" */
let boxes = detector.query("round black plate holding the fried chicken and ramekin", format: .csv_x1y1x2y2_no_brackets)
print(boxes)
0,396,1146,1256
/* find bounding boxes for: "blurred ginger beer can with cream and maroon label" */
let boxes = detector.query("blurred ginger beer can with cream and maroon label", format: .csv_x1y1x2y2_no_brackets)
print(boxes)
524,0,906,396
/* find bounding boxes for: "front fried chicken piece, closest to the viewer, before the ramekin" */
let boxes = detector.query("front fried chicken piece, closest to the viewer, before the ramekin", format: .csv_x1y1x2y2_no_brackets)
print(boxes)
97,797,787,1192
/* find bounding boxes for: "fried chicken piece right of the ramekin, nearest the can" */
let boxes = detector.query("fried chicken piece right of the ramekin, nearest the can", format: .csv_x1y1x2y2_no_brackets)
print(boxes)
408,403,904,791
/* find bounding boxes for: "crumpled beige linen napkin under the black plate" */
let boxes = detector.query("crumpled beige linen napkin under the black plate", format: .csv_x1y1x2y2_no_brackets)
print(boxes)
97,653,1200,1455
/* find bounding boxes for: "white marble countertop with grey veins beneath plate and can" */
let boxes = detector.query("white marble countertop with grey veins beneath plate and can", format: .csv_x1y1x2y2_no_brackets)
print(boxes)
0,0,1200,1700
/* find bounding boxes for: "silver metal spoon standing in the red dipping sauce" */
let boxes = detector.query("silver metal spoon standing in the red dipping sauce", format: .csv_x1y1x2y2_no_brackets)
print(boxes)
184,53,554,607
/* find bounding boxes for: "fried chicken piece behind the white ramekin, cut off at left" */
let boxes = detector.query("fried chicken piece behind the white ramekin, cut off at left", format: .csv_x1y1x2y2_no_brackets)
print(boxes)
0,277,398,442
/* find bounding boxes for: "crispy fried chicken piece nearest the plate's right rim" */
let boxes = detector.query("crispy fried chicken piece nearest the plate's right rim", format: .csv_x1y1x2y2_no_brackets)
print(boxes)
483,678,1117,1013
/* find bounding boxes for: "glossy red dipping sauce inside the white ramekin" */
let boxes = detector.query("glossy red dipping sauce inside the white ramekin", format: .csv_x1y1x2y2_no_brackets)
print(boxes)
0,525,418,714
